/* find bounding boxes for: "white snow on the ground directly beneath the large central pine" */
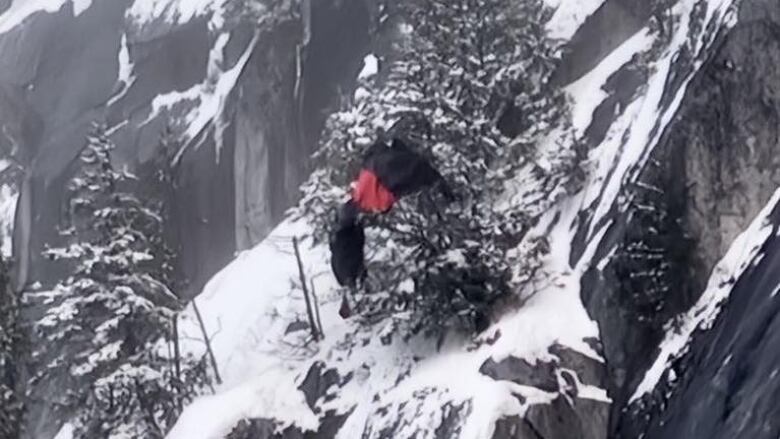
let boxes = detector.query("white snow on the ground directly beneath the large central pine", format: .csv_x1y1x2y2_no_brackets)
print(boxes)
169,211,607,439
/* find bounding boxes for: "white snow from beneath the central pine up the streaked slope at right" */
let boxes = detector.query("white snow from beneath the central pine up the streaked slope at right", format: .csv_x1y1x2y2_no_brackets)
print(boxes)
169,0,744,439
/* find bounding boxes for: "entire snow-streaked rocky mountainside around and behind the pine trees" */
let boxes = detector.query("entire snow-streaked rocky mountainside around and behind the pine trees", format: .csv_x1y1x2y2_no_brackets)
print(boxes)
0,0,780,439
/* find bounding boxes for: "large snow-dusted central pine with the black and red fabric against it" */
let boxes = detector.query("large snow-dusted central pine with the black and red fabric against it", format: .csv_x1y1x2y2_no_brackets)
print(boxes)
299,0,566,333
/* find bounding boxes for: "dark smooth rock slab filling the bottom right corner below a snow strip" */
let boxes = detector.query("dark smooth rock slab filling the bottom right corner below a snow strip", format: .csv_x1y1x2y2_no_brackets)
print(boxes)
632,202,780,439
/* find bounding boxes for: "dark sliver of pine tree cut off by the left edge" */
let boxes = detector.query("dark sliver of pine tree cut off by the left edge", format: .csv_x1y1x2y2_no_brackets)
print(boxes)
0,257,24,438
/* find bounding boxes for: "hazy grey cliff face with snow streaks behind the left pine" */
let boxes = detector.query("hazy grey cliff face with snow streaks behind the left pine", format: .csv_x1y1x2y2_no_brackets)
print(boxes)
0,0,372,300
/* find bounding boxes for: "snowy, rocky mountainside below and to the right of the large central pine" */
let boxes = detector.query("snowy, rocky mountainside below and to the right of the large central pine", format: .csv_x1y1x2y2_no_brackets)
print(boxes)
166,2,778,438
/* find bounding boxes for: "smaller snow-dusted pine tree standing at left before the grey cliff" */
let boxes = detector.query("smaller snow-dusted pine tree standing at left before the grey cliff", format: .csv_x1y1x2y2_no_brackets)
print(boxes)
35,127,203,438
